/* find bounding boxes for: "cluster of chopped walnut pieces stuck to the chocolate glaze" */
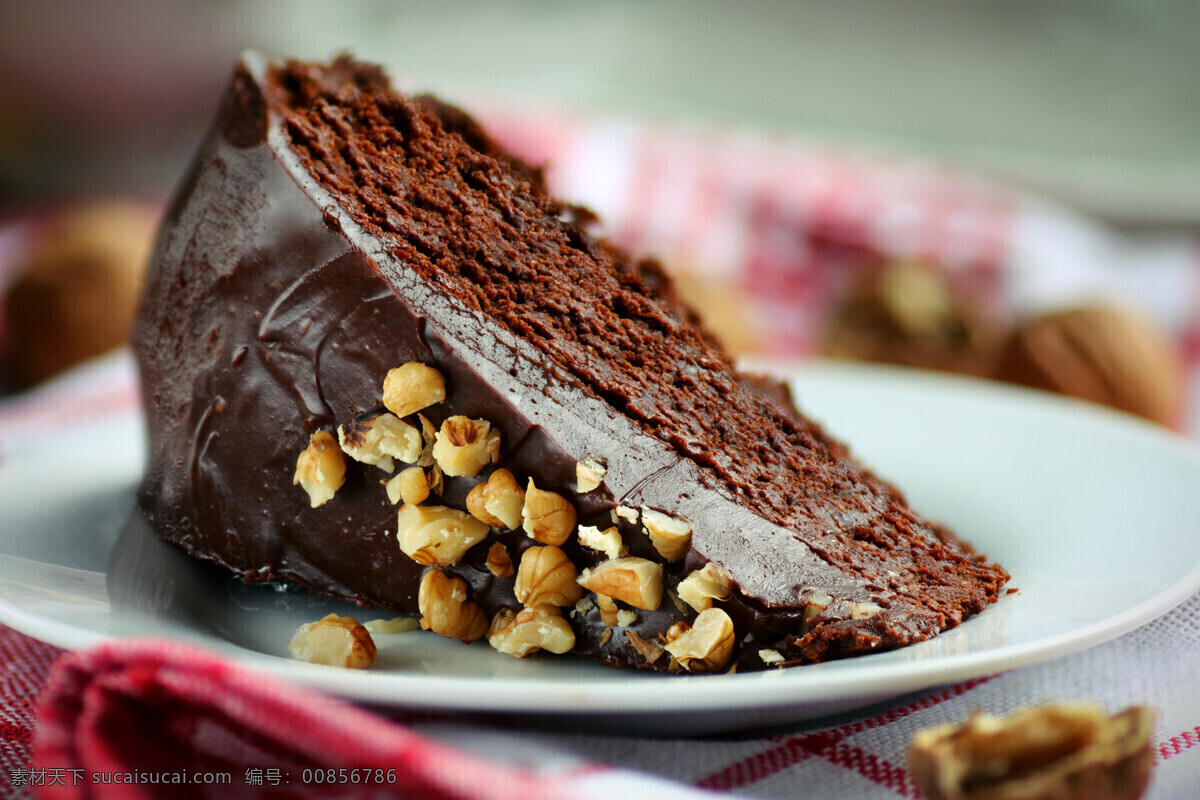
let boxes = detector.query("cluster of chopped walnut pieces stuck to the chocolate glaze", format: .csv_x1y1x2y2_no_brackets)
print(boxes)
295,362,733,670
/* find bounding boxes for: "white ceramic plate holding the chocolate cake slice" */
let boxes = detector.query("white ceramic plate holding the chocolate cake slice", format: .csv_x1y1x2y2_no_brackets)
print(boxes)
0,363,1200,734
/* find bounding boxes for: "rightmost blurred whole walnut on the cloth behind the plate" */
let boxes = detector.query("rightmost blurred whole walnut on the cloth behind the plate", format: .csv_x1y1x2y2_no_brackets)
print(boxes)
995,306,1184,426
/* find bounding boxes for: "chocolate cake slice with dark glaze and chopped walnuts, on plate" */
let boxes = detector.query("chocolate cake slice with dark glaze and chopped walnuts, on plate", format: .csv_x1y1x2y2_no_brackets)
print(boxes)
136,54,1008,673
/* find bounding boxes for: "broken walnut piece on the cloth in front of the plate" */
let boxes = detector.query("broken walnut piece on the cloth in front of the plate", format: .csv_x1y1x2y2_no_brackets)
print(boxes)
908,704,1154,800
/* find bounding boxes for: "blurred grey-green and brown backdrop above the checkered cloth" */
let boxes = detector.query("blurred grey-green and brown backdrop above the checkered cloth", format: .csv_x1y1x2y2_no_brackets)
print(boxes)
0,0,1200,223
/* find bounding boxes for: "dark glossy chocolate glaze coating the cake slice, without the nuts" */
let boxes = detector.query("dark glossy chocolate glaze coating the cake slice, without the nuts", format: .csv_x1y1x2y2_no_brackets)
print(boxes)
136,56,1007,669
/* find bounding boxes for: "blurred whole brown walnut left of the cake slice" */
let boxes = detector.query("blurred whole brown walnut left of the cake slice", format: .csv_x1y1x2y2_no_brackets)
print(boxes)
5,201,155,389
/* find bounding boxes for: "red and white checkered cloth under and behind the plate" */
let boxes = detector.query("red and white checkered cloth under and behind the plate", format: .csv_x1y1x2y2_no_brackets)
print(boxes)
7,107,1200,800
